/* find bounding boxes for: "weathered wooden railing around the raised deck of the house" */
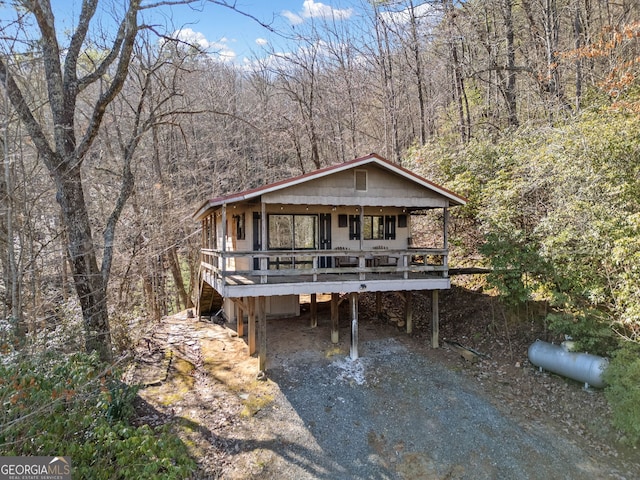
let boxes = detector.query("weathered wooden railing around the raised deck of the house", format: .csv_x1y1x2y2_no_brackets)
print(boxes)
201,247,449,284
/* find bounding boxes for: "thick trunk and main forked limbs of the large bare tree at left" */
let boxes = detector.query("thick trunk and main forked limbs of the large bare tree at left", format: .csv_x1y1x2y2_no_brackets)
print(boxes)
0,0,140,361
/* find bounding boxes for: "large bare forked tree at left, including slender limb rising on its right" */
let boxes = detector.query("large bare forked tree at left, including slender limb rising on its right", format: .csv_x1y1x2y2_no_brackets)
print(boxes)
0,0,220,360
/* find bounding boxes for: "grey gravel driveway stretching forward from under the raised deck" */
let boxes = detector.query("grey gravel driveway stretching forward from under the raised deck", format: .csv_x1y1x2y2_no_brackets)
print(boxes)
230,323,627,480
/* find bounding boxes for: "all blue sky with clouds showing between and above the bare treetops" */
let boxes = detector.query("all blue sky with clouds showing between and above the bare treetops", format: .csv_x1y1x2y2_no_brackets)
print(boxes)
0,0,432,65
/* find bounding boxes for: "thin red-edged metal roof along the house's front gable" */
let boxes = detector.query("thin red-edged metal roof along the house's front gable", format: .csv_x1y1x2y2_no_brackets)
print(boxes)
193,153,467,220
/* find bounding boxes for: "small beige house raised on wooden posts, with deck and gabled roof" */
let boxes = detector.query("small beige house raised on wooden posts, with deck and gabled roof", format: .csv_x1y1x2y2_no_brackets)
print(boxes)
194,154,465,370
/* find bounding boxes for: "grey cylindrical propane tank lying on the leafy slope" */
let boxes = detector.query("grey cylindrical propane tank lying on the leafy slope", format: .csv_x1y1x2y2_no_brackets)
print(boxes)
528,340,609,388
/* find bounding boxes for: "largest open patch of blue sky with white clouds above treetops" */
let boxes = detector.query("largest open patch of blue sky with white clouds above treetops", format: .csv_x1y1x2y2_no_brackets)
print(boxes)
154,0,355,63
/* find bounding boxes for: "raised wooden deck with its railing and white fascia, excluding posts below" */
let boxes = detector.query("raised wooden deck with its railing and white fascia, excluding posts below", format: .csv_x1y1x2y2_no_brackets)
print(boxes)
202,249,450,298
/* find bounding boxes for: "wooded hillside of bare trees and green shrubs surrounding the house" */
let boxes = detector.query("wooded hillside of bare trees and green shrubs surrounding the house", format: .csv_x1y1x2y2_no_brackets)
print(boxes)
0,0,640,478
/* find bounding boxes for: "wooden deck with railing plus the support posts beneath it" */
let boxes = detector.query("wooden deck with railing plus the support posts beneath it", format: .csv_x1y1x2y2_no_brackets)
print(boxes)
199,248,451,371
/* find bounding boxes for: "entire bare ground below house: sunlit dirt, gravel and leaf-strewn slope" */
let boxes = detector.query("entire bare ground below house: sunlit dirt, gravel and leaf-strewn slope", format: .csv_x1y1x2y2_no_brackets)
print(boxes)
128,288,640,479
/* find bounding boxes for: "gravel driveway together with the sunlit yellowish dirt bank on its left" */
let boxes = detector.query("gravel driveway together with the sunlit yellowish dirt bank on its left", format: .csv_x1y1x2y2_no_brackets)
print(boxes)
134,310,640,480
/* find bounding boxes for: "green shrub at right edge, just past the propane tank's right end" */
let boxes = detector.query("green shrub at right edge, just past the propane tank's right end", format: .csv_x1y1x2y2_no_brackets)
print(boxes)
604,342,640,445
